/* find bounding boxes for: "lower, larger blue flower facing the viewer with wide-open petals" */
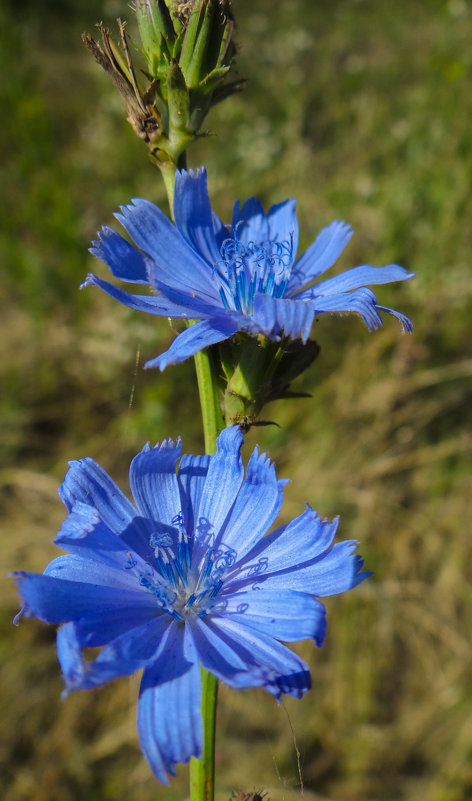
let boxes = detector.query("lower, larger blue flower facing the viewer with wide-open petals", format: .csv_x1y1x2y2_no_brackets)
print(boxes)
14,427,367,782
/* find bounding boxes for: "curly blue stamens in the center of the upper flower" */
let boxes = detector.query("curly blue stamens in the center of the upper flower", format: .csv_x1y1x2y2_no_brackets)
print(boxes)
213,231,293,314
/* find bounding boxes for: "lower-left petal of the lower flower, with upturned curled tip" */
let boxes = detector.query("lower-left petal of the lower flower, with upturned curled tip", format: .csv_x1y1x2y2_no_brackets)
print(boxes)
57,614,172,691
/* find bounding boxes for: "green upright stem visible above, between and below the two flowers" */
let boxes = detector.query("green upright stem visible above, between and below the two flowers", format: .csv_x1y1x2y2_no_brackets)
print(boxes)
161,154,225,801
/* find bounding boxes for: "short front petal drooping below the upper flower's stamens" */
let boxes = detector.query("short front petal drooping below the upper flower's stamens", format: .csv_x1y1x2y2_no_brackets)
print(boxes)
254,295,316,342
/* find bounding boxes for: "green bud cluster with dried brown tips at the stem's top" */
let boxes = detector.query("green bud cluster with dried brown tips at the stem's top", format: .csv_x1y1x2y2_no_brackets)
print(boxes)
83,0,242,175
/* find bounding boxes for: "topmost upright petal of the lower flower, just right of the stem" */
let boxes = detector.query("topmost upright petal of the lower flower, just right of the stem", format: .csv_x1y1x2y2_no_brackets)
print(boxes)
195,426,244,558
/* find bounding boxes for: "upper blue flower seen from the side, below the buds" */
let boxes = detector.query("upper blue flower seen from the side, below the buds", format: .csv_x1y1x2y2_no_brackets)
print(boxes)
84,168,413,370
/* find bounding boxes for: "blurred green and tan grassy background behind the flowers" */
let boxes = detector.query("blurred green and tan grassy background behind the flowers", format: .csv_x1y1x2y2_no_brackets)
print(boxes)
0,0,472,801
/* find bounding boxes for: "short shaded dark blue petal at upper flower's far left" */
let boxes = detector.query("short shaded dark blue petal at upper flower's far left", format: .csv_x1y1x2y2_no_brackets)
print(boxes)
89,225,148,284
